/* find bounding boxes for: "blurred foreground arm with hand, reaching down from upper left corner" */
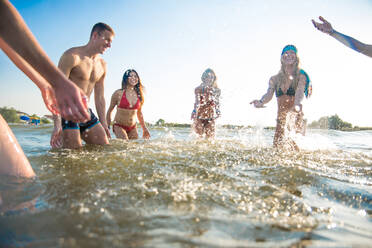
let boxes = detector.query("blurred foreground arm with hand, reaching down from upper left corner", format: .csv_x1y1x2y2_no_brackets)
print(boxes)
0,0,89,122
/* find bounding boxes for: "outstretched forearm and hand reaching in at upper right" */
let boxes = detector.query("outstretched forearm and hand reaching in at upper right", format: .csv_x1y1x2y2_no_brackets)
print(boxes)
311,16,372,57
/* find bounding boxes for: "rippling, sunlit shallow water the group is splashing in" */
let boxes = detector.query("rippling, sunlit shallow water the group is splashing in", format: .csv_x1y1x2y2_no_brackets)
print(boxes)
0,126,372,247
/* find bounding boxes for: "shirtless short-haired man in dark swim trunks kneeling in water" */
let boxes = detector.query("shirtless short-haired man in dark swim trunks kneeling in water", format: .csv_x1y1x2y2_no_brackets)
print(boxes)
50,23,114,149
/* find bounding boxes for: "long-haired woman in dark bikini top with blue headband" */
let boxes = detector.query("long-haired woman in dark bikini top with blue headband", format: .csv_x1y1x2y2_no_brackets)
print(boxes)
251,45,311,150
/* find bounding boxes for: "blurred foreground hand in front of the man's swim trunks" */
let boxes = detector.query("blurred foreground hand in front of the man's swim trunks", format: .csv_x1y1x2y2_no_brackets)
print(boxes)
54,78,90,123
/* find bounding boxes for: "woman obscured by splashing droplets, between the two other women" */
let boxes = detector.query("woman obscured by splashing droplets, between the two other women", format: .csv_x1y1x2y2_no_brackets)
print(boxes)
191,69,221,138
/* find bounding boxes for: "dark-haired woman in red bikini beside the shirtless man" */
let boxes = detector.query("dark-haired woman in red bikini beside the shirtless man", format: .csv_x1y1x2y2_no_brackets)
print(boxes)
106,69,150,139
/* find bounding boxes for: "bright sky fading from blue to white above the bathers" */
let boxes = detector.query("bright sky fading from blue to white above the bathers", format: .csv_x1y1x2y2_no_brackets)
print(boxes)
0,0,372,126
